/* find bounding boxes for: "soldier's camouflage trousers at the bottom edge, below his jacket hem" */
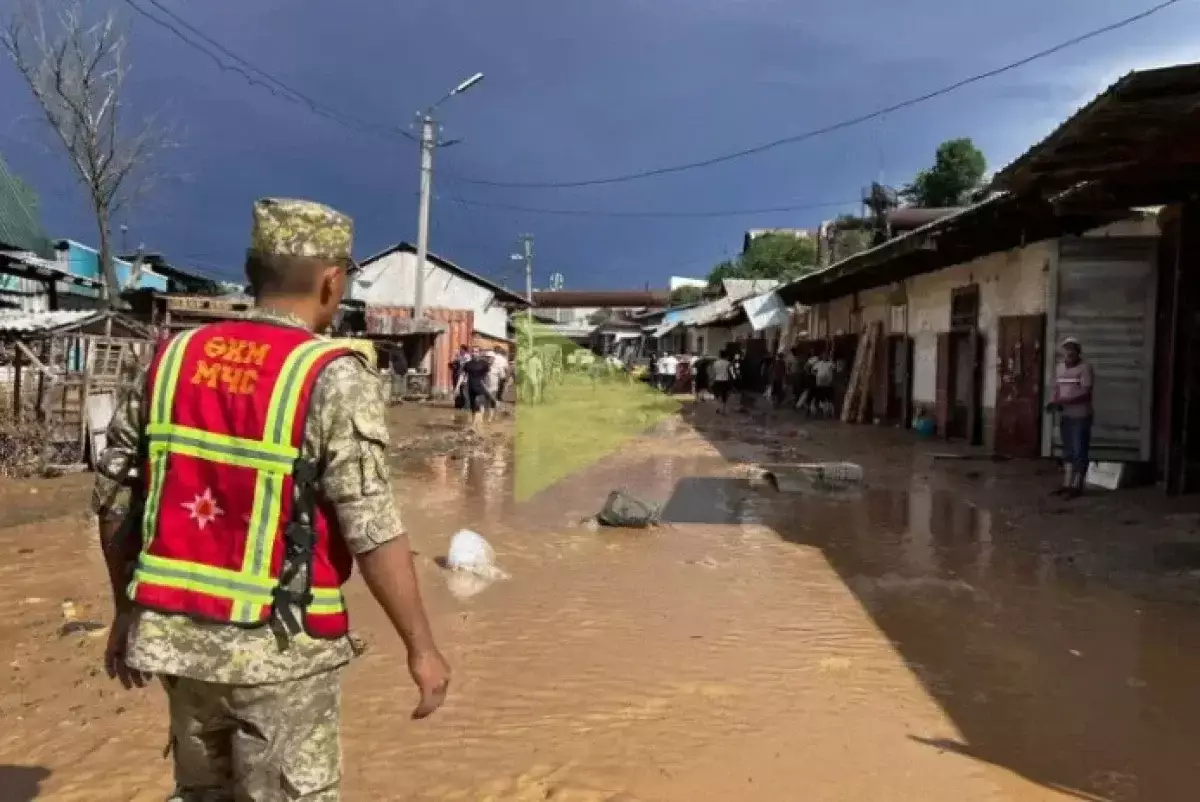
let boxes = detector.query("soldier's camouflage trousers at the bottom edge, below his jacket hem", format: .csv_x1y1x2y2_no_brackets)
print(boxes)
163,670,341,802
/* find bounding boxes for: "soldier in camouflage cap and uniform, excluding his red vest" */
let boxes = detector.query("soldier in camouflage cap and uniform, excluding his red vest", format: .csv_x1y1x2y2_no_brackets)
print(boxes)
95,199,450,802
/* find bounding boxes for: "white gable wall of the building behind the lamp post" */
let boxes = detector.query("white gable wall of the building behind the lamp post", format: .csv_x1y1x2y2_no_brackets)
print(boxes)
350,251,509,340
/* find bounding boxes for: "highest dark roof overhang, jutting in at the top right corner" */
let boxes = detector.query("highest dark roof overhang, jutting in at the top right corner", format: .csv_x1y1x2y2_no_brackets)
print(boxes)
991,64,1200,193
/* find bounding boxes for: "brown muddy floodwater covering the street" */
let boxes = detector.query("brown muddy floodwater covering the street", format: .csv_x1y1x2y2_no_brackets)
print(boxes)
0,410,1200,802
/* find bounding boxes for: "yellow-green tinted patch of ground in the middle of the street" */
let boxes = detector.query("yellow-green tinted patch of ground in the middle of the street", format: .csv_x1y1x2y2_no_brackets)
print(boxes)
515,371,679,501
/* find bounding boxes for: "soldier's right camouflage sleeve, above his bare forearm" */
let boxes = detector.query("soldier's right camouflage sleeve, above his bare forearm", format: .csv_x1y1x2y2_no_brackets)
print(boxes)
306,357,404,555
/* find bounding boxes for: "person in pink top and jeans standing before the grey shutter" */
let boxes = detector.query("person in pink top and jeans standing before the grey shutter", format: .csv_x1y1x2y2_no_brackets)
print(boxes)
1046,337,1096,498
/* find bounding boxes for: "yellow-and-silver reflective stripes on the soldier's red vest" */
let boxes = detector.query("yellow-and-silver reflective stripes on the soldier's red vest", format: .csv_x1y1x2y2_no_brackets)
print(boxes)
128,329,355,624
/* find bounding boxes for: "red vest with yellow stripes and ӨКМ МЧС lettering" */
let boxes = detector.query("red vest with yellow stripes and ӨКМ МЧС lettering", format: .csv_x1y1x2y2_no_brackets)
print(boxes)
130,321,355,638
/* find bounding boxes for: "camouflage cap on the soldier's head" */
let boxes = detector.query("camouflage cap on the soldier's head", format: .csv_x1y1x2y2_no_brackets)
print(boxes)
250,198,354,261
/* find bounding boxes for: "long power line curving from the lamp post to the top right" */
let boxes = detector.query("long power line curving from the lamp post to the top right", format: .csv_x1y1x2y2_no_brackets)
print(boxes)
442,0,1180,190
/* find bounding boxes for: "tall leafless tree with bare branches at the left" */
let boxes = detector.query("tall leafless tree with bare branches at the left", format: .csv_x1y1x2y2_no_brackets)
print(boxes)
0,0,172,306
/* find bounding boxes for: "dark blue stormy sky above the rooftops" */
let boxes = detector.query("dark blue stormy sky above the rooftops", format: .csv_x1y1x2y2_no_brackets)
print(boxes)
0,0,1200,288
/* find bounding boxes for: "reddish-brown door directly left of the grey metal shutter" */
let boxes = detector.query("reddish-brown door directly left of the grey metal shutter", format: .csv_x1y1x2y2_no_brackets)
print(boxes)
996,315,1045,457
